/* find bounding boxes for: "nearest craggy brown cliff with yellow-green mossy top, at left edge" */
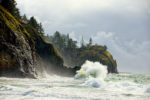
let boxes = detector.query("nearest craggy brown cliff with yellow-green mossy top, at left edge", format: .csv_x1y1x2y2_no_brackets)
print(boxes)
0,6,36,77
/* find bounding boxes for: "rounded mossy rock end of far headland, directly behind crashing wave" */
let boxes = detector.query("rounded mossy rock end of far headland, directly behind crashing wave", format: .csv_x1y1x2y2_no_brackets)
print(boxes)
79,45,118,73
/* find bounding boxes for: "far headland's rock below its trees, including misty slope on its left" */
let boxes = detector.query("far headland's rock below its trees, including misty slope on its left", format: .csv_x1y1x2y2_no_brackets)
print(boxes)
62,45,118,73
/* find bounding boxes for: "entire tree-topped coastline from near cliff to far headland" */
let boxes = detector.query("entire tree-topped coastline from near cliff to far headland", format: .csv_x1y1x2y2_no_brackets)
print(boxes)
0,0,117,77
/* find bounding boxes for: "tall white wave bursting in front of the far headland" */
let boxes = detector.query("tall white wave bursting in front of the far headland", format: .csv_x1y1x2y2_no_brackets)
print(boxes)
75,60,108,87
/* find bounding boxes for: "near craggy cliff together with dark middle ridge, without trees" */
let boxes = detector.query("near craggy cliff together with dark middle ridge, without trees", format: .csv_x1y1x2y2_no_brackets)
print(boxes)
0,6,68,78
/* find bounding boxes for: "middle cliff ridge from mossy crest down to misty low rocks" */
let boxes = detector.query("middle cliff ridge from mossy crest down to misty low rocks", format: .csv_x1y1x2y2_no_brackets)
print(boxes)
22,23,76,76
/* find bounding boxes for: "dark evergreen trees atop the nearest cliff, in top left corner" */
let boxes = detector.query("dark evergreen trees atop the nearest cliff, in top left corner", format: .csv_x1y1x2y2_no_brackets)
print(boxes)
0,0,21,19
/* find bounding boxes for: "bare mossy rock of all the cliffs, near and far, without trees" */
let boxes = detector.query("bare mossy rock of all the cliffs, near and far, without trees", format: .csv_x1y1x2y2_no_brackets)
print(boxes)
0,6,117,78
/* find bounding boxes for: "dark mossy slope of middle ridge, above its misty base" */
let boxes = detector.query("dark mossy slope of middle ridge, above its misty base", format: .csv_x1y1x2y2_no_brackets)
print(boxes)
22,23,63,66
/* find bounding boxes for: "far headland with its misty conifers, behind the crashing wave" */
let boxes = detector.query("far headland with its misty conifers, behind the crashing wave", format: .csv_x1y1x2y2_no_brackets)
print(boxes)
46,31,117,73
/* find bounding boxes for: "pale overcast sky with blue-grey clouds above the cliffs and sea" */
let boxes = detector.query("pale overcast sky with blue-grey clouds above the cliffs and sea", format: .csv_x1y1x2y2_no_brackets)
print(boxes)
17,0,150,74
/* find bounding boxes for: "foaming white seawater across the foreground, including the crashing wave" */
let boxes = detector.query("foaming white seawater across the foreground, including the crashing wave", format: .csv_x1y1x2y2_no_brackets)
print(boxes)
0,61,150,100
